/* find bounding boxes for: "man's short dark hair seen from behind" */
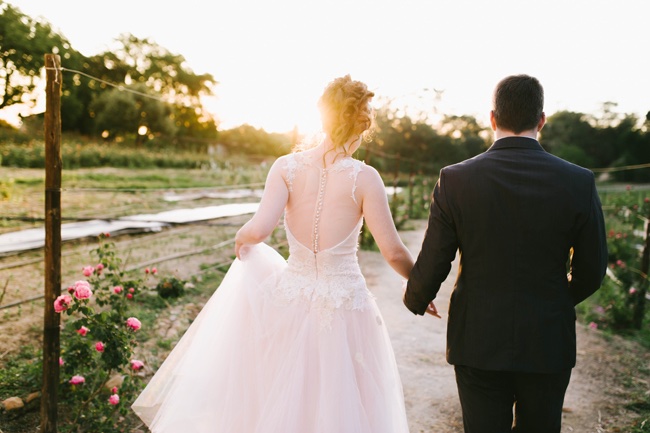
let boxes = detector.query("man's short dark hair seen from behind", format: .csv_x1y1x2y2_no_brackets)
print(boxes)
492,75,544,134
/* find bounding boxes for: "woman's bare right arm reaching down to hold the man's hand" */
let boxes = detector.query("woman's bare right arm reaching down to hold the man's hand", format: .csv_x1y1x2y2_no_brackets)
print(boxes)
359,167,413,278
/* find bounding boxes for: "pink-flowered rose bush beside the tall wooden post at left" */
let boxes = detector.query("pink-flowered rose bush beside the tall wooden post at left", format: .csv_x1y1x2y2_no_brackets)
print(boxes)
54,235,155,433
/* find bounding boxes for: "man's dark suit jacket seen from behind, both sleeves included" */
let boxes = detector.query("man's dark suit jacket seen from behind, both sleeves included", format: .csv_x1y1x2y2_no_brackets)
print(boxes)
404,137,607,373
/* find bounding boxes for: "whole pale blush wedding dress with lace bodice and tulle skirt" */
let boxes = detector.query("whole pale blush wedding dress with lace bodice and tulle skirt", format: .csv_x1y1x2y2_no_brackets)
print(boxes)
132,153,408,433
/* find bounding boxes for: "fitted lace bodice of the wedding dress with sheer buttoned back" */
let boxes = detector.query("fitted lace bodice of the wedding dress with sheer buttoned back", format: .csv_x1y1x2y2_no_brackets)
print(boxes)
268,153,371,327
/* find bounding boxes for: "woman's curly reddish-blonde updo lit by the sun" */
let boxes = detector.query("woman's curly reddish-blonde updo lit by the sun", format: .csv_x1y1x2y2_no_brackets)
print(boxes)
318,75,375,155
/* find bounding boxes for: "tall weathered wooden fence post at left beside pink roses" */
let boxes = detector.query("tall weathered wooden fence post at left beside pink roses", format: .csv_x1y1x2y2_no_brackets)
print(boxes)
40,54,63,433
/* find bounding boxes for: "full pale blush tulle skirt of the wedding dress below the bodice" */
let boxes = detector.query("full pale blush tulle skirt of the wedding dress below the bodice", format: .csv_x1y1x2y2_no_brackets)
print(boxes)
132,244,408,433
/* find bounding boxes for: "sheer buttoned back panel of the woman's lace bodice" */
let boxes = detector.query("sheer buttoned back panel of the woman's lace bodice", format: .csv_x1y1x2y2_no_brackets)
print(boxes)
285,153,363,254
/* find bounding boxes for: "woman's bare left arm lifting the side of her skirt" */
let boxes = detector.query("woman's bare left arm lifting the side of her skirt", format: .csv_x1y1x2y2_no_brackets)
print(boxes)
235,159,289,259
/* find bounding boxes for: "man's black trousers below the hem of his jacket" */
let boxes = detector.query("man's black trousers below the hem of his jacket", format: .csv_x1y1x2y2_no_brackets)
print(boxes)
454,365,571,433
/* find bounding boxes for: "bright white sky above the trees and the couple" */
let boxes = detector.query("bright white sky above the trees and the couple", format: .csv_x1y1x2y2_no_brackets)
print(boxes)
7,0,650,132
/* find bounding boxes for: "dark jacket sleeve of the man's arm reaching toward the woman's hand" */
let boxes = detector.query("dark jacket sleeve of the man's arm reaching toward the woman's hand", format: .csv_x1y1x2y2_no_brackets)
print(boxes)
404,169,458,315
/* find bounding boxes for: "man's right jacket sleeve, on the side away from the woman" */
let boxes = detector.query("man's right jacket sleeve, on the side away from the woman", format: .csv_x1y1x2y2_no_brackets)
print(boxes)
569,175,607,305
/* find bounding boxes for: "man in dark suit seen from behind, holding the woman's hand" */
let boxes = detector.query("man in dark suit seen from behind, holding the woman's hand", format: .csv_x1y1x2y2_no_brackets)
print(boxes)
404,75,607,433
